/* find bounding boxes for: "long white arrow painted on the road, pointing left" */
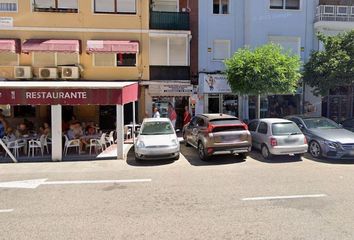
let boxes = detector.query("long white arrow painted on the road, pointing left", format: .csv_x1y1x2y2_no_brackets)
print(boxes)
0,178,152,189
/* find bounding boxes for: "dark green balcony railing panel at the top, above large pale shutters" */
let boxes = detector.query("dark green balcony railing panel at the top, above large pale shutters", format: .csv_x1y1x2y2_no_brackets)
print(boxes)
150,11,190,30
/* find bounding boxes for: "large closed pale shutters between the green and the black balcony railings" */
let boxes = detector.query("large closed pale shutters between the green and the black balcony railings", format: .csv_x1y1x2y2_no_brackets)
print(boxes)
150,37,189,66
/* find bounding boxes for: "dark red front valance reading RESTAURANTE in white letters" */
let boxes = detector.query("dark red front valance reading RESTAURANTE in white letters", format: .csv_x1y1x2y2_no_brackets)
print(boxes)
0,88,123,105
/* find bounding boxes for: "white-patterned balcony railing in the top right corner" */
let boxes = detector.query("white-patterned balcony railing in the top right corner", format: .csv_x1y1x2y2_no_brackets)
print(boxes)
315,5,354,22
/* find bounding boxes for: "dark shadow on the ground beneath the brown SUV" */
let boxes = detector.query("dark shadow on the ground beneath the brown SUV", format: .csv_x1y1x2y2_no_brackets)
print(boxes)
181,145,246,166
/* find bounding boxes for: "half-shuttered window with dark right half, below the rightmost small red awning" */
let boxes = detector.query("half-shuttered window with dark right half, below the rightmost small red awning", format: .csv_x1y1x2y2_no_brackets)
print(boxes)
93,53,136,67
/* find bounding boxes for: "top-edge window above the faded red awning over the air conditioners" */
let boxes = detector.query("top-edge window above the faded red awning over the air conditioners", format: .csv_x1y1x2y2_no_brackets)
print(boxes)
33,0,78,13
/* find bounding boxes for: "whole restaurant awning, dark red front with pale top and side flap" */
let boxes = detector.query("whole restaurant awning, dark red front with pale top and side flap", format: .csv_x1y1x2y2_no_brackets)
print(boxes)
0,81,138,105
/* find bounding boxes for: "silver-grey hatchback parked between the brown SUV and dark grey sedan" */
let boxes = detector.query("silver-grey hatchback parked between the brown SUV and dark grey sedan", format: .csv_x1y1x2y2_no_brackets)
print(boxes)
248,118,308,159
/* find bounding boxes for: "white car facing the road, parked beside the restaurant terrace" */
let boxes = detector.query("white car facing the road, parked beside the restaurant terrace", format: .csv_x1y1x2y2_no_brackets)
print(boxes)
134,118,180,160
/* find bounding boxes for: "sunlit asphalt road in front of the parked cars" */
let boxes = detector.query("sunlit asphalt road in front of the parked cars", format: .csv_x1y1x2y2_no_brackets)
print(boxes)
0,146,354,240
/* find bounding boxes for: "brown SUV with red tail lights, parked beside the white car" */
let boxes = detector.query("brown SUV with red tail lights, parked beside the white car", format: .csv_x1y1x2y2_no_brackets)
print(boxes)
183,114,252,161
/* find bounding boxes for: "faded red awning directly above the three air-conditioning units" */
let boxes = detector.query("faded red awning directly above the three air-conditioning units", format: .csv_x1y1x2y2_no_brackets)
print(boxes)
22,39,81,53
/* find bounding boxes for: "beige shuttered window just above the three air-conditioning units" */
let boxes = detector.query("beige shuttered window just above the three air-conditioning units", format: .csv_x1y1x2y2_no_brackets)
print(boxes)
32,52,79,67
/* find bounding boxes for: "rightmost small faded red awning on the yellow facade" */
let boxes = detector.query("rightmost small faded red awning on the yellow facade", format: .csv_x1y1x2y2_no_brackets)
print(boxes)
86,40,139,53
